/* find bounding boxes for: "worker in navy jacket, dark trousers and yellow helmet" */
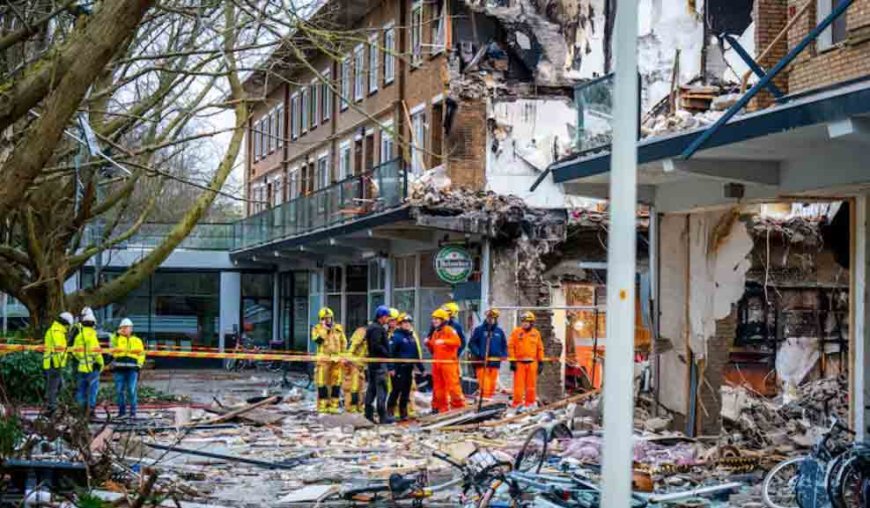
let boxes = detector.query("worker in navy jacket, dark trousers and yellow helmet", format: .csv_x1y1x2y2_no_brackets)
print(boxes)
387,313,425,421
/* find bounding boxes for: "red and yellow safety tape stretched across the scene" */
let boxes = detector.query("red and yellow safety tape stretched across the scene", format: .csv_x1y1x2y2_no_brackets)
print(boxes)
0,344,564,365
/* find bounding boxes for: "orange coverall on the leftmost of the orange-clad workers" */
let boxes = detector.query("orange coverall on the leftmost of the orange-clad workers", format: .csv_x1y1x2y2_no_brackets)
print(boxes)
426,325,465,413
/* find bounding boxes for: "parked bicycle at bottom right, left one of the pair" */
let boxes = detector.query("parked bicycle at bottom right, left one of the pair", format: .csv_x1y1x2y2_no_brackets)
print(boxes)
762,418,854,508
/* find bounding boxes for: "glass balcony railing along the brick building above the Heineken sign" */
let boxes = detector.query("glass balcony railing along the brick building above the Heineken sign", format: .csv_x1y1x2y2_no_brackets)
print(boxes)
233,159,408,250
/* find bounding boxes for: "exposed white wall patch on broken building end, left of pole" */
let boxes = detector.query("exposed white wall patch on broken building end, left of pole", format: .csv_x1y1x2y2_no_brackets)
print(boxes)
486,98,594,208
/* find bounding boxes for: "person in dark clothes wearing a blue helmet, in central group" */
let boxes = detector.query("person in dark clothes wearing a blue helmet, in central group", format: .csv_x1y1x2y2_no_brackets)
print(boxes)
365,305,394,424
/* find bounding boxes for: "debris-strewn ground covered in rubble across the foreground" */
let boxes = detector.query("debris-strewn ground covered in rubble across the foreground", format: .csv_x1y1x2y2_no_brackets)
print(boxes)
0,371,845,507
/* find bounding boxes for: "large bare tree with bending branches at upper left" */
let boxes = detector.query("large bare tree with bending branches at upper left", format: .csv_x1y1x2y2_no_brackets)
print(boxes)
0,0,255,327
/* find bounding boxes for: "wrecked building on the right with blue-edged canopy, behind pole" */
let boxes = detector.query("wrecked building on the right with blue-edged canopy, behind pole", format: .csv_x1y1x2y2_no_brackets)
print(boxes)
542,0,870,439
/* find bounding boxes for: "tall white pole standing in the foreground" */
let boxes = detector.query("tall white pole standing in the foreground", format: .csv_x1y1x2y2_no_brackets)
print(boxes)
601,0,638,508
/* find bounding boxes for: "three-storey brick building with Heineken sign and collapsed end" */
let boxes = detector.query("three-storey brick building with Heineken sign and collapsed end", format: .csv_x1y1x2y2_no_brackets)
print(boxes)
231,0,603,392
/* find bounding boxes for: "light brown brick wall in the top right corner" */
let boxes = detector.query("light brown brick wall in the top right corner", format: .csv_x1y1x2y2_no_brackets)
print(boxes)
788,0,870,93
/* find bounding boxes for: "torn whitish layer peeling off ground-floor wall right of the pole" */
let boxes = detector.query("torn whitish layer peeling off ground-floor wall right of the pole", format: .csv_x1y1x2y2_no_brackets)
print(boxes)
689,210,753,355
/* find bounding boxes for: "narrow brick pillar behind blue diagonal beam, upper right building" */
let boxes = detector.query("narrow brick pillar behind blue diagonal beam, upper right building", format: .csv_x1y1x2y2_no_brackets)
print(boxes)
750,0,792,109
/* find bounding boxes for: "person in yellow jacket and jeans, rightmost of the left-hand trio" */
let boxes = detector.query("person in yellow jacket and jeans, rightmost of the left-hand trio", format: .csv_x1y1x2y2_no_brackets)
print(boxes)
112,318,145,418
